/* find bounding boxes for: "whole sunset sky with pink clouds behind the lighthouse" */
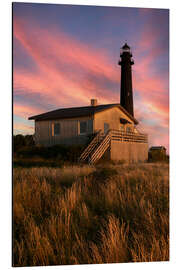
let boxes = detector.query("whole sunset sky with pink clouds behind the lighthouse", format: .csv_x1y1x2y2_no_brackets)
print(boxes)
13,3,169,151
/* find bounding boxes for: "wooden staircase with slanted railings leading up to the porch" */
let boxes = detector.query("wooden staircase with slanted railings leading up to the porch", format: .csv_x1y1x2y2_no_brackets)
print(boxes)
78,130,111,164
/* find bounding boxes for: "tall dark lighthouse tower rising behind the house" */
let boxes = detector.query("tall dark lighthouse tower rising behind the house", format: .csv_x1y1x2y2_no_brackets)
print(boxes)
118,43,134,116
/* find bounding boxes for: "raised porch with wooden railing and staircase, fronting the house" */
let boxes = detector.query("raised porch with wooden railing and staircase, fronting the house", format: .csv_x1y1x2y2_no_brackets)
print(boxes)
79,129,148,164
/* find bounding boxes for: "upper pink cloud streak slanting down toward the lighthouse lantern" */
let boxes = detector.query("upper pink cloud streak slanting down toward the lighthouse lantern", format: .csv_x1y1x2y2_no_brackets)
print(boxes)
14,18,118,80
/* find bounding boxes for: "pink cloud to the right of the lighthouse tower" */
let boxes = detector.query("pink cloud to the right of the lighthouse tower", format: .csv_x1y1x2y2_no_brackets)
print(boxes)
133,28,169,126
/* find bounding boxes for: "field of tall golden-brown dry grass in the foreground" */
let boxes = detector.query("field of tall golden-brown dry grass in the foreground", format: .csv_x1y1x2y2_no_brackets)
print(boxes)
13,164,169,266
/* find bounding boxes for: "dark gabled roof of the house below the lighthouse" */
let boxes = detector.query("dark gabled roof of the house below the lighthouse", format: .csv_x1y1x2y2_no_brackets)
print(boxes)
28,104,138,124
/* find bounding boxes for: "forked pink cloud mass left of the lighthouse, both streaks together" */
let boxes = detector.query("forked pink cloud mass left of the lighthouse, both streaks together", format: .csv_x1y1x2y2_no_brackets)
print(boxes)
14,17,118,109
